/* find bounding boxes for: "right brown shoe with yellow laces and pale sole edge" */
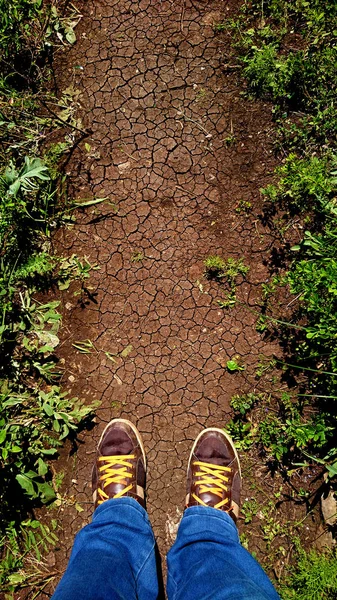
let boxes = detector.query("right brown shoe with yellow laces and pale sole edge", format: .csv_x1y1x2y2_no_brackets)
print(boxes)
186,427,241,522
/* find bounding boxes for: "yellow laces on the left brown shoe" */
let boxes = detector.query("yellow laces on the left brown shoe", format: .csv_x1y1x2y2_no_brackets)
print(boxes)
97,454,135,504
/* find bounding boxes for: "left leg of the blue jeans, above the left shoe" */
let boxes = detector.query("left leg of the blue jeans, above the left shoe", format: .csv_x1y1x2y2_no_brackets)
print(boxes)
52,498,158,600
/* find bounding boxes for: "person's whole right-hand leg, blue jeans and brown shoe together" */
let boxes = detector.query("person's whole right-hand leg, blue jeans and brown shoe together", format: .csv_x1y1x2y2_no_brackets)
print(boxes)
167,428,279,600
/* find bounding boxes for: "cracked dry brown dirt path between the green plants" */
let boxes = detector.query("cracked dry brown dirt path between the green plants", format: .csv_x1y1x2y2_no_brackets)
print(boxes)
51,0,275,570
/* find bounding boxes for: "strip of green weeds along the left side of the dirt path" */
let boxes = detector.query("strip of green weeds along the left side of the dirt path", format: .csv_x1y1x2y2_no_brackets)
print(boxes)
0,0,97,597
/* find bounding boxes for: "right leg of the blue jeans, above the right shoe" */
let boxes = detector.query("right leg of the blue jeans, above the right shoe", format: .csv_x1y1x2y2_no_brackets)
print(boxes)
167,506,279,600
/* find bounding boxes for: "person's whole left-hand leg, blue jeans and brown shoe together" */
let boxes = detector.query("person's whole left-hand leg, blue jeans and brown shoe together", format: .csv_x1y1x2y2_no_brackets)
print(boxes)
52,419,158,600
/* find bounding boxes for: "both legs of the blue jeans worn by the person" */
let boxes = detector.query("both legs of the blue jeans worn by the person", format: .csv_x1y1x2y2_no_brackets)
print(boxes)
52,498,279,600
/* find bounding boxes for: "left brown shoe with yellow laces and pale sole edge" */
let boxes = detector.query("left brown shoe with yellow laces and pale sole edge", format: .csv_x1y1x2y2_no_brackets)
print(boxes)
92,419,146,508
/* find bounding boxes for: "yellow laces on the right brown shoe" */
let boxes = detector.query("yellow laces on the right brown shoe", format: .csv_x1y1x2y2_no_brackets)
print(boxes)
192,461,231,508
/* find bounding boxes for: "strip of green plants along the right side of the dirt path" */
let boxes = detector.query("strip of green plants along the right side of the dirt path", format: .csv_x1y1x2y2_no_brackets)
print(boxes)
219,0,337,599
